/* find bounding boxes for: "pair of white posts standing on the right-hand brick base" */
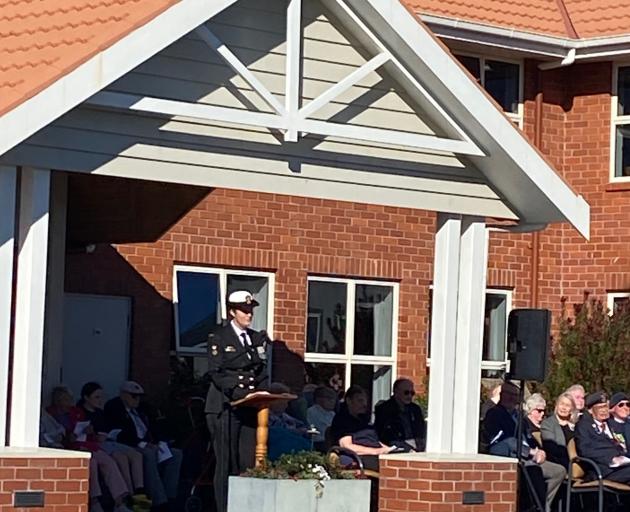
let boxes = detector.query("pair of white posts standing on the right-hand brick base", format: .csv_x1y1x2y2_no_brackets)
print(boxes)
427,213,488,454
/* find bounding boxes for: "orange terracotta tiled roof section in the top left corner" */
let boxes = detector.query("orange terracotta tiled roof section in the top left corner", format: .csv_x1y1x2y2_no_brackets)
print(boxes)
0,0,177,115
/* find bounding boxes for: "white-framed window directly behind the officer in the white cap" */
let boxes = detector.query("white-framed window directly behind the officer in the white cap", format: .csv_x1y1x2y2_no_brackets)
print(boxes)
173,265,274,355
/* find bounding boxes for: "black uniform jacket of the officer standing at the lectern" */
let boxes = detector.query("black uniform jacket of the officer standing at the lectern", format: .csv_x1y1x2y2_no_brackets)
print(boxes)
206,324,268,414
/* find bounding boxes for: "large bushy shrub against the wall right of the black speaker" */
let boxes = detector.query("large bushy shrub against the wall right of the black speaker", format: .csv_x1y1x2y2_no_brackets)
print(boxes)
544,294,630,403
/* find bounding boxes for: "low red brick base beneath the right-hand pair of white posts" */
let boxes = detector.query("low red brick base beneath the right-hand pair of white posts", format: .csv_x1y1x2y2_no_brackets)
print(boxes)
378,458,516,512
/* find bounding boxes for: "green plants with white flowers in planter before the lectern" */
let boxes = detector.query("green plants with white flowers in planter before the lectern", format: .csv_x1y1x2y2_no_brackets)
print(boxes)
243,451,355,480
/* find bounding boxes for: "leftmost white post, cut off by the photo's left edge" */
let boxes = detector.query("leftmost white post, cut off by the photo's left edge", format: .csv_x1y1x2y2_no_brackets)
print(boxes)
0,166,17,447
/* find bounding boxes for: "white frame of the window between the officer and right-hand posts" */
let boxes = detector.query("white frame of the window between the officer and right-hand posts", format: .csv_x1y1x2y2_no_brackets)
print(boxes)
304,276,400,389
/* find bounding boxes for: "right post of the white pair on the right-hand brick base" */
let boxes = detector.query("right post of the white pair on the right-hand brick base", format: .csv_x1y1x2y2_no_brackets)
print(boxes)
452,217,488,454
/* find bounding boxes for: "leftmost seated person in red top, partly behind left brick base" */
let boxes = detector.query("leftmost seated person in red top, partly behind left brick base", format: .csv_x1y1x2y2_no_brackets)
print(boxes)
47,386,132,512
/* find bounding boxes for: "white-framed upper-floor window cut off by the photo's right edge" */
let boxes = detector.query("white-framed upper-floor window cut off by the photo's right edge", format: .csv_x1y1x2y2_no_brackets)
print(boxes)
610,66,630,180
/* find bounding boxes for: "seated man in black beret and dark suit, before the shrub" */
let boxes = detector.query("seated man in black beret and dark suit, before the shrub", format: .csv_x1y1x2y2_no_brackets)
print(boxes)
575,391,630,484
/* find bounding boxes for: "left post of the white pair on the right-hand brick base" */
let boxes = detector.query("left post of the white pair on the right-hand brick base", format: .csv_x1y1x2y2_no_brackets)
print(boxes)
427,213,462,453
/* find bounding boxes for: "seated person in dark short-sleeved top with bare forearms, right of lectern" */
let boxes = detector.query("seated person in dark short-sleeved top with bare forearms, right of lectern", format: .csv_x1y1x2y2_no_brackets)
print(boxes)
330,386,392,471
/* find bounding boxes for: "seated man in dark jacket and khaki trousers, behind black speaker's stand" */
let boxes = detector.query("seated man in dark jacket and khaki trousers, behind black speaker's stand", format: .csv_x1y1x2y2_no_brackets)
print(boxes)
482,382,566,511
